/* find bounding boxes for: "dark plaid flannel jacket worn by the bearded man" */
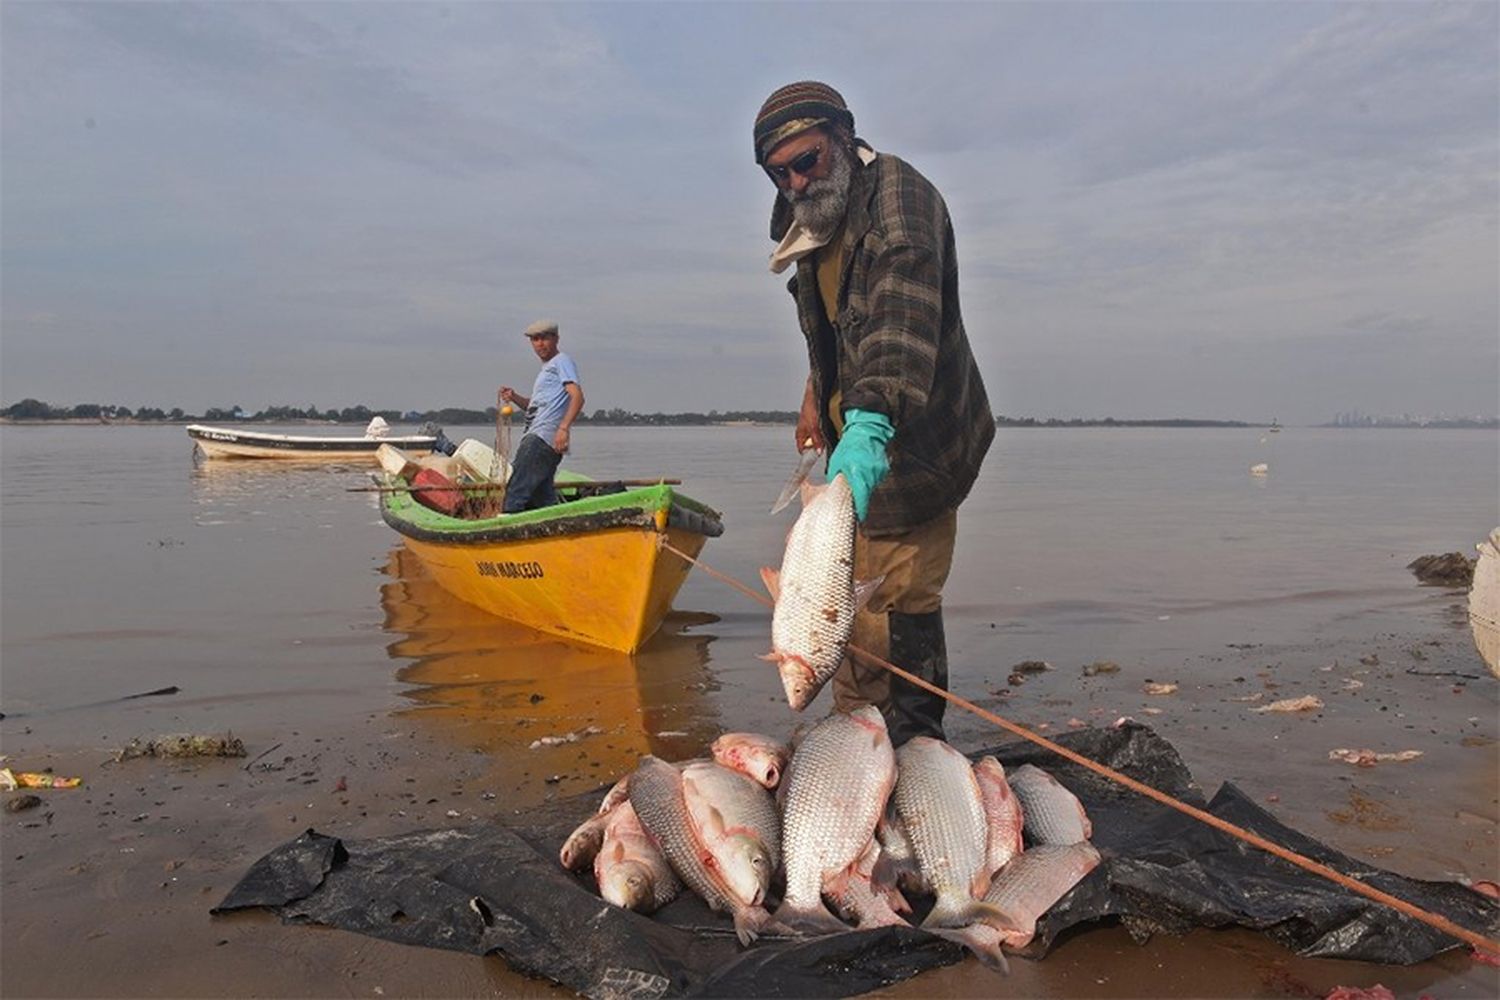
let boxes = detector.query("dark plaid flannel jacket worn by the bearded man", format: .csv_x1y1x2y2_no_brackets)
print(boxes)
771,153,995,538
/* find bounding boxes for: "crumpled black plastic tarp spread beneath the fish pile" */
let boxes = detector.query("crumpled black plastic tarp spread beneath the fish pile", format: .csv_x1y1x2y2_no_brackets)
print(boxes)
213,724,1500,997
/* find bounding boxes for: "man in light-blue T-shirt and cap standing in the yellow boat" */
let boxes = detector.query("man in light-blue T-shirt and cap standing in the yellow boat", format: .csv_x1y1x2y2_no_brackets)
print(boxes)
500,319,584,514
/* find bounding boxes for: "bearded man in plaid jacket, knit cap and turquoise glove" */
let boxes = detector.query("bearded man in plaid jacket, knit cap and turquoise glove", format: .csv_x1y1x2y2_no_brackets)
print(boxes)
755,81,995,745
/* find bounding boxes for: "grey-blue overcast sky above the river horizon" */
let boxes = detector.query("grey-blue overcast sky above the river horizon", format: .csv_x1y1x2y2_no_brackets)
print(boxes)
0,0,1500,423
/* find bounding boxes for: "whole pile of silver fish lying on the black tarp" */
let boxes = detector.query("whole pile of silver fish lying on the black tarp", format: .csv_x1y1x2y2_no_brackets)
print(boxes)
561,706,1100,969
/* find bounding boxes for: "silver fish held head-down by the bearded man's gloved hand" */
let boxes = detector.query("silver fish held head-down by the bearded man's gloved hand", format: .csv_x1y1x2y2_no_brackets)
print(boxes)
761,474,873,712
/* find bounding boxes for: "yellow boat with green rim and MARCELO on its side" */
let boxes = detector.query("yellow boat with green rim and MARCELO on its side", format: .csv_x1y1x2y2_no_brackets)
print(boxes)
381,474,723,652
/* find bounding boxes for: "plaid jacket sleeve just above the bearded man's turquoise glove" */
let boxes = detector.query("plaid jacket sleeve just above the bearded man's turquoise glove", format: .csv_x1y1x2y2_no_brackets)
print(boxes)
843,241,942,427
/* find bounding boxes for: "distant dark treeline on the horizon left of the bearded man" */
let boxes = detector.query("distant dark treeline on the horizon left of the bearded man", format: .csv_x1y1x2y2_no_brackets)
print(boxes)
0,399,797,427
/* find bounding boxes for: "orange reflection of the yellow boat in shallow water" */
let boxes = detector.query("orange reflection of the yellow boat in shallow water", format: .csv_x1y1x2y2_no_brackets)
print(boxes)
381,546,720,793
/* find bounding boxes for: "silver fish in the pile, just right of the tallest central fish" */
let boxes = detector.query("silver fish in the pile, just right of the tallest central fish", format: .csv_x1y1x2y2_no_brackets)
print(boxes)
893,736,995,928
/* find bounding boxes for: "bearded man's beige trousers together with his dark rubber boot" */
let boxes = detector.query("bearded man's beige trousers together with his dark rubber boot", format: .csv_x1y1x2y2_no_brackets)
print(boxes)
833,511,959,747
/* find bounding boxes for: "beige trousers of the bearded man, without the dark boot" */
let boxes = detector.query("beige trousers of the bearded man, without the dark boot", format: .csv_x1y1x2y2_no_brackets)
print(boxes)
834,510,959,712
